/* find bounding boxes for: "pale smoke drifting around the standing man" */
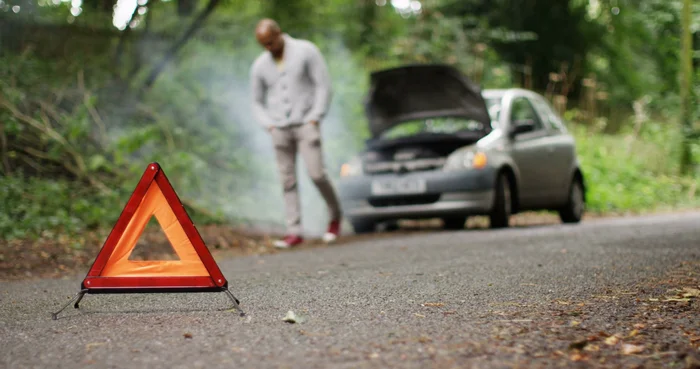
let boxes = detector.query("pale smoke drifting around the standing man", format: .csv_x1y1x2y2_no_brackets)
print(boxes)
155,34,364,237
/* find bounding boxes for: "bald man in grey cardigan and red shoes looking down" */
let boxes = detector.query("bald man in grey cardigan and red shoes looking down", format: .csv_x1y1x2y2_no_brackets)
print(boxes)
250,19,341,248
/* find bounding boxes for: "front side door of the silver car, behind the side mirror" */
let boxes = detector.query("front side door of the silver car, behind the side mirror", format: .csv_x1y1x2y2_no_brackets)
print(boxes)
508,95,554,209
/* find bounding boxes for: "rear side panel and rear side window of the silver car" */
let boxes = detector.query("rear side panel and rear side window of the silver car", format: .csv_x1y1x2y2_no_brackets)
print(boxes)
532,96,576,206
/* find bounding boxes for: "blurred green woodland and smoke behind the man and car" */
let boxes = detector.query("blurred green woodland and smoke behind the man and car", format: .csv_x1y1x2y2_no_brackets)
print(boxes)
0,0,700,242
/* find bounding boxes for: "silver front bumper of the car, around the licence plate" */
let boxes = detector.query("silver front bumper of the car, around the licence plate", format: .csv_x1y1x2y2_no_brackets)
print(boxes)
339,168,496,221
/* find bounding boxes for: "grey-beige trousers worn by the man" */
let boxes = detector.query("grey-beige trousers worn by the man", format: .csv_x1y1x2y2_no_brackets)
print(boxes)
271,123,341,235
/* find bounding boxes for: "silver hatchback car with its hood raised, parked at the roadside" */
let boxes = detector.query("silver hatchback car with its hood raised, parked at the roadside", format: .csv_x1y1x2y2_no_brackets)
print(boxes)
339,64,586,233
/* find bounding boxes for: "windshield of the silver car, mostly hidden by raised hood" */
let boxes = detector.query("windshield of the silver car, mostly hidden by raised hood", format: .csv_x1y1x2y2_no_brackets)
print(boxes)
381,98,501,138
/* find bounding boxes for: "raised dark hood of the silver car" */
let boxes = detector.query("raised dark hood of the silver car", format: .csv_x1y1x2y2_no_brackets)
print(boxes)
365,64,491,138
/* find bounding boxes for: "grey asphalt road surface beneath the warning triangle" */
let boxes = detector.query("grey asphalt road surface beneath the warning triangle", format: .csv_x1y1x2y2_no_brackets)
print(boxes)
0,213,700,368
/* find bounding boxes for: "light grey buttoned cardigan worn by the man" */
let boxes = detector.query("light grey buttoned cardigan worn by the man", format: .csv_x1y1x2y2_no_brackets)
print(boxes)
250,33,332,127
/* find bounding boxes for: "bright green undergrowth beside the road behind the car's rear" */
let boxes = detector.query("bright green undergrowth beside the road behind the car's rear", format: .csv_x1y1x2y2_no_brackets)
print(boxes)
572,123,700,213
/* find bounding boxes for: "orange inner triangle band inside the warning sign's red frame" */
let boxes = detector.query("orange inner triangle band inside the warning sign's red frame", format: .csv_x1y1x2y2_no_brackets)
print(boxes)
101,182,209,277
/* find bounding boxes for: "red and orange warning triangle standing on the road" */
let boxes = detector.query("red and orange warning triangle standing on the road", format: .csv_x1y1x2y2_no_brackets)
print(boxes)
82,163,228,293
